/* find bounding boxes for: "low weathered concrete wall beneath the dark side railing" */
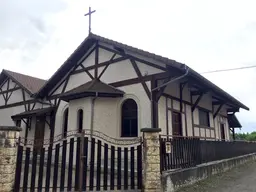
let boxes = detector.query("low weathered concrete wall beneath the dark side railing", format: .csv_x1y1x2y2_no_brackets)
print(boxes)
161,153,256,192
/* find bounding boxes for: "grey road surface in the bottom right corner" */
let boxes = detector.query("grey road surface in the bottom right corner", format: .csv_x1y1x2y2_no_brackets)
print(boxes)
178,162,256,192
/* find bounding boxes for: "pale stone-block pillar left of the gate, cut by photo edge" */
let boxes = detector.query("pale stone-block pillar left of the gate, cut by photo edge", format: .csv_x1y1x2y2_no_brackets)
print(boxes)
0,126,21,192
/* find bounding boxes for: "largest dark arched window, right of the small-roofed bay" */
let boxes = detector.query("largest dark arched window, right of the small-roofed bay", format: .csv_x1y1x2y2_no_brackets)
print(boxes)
121,99,138,137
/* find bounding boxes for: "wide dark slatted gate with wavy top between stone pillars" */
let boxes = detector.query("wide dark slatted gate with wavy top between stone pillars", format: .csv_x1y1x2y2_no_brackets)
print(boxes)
14,130,142,192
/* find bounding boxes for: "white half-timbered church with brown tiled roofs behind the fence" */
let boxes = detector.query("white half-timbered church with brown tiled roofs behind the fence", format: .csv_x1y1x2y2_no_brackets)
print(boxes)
0,33,249,143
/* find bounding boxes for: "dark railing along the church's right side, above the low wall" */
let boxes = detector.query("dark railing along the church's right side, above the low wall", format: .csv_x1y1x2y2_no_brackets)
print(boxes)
160,136,256,171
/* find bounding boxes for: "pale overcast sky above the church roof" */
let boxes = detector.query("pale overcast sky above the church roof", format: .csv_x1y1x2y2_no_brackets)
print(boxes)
0,0,256,132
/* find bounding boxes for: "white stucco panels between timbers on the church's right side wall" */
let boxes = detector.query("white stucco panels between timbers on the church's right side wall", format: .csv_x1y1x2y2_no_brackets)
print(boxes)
158,82,230,140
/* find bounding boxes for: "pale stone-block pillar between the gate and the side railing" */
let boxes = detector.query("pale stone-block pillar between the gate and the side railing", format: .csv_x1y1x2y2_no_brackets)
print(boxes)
141,128,161,192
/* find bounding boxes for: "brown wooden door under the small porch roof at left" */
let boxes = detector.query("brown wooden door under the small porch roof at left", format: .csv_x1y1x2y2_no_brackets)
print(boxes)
34,117,45,149
